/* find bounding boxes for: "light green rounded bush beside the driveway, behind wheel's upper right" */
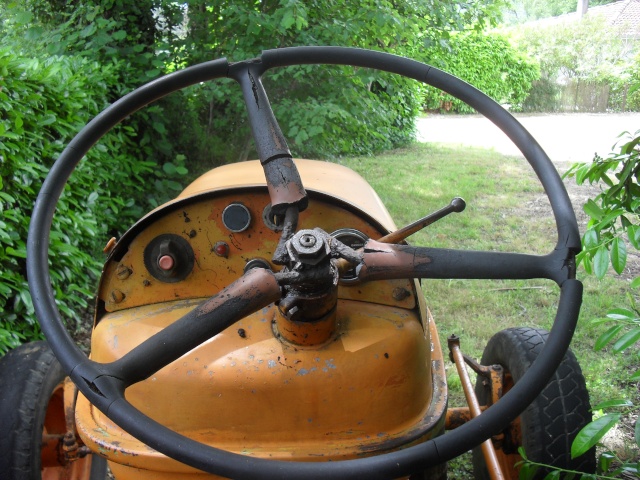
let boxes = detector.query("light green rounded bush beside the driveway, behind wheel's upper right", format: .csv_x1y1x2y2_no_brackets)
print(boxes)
425,32,540,113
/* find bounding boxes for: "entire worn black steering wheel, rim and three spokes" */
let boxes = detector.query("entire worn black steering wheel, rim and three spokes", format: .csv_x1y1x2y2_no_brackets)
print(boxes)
27,47,582,479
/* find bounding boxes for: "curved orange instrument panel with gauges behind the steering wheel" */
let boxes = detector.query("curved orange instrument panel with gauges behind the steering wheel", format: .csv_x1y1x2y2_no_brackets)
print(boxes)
98,187,416,320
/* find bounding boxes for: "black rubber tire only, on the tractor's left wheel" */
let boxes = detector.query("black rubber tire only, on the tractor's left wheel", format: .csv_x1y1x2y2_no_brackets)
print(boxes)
0,342,107,480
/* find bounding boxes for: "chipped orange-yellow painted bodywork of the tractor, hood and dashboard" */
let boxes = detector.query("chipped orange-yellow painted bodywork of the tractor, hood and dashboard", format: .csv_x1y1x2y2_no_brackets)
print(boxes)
76,161,447,480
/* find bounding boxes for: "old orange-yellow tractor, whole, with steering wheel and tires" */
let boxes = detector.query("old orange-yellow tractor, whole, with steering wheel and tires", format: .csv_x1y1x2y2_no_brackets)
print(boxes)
0,47,595,480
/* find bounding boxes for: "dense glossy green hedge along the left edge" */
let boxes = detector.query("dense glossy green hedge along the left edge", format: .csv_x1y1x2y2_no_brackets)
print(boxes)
0,45,185,354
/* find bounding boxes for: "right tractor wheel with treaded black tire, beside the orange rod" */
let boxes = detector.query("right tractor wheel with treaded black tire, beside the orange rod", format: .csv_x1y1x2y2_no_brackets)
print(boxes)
473,327,596,479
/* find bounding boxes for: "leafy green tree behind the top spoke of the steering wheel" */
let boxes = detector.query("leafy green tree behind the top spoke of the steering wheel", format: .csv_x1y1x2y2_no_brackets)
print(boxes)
150,0,498,163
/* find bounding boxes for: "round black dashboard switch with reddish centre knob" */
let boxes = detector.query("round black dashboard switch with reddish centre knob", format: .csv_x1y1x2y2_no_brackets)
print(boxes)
144,234,194,283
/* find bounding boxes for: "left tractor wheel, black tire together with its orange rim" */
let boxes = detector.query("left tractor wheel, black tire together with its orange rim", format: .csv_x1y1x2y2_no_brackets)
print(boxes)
0,342,107,480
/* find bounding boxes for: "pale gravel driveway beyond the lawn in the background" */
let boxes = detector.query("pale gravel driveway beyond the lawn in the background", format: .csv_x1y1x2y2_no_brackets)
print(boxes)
417,113,640,170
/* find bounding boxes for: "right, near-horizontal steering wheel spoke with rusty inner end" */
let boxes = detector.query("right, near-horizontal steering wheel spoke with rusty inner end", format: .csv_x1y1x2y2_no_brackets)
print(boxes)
356,240,575,285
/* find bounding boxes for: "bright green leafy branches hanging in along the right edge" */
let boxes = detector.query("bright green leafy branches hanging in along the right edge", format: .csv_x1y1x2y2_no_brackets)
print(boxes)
548,130,640,478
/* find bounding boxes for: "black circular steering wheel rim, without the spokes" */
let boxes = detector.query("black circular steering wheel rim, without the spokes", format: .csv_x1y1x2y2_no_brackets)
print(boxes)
27,47,582,479
